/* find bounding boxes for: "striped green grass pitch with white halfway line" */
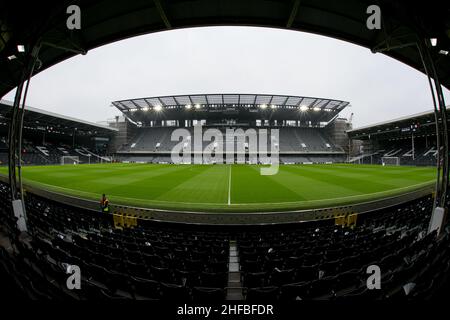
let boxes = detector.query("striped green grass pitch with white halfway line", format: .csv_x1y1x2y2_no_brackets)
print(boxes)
0,164,436,212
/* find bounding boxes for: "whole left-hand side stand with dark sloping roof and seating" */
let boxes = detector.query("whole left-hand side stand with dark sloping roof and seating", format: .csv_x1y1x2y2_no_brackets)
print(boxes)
0,100,118,165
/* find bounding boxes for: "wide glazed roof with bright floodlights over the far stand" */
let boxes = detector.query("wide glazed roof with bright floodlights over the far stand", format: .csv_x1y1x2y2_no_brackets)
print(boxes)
112,93,349,123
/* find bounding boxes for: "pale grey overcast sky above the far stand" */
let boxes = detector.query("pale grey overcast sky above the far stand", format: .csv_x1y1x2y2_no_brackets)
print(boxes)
4,27,450,127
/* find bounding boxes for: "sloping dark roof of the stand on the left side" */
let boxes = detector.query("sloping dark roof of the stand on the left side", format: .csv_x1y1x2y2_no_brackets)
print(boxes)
0,100,118,135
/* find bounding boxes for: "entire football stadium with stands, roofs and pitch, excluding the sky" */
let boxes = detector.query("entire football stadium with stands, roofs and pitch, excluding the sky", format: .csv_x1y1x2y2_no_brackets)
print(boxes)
0,1,450,304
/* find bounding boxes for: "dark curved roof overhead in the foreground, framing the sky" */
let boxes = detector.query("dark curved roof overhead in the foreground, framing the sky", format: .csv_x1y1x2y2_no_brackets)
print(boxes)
0,0,450,97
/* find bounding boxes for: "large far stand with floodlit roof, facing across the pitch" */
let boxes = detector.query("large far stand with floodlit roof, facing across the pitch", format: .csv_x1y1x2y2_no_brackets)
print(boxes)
111,94,350,163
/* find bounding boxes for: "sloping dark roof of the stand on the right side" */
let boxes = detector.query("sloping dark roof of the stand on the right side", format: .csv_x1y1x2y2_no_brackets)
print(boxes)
347,107,450,140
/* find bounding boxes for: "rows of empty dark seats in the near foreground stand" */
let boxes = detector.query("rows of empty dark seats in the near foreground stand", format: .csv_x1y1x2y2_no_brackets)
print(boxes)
0,179,450,301
